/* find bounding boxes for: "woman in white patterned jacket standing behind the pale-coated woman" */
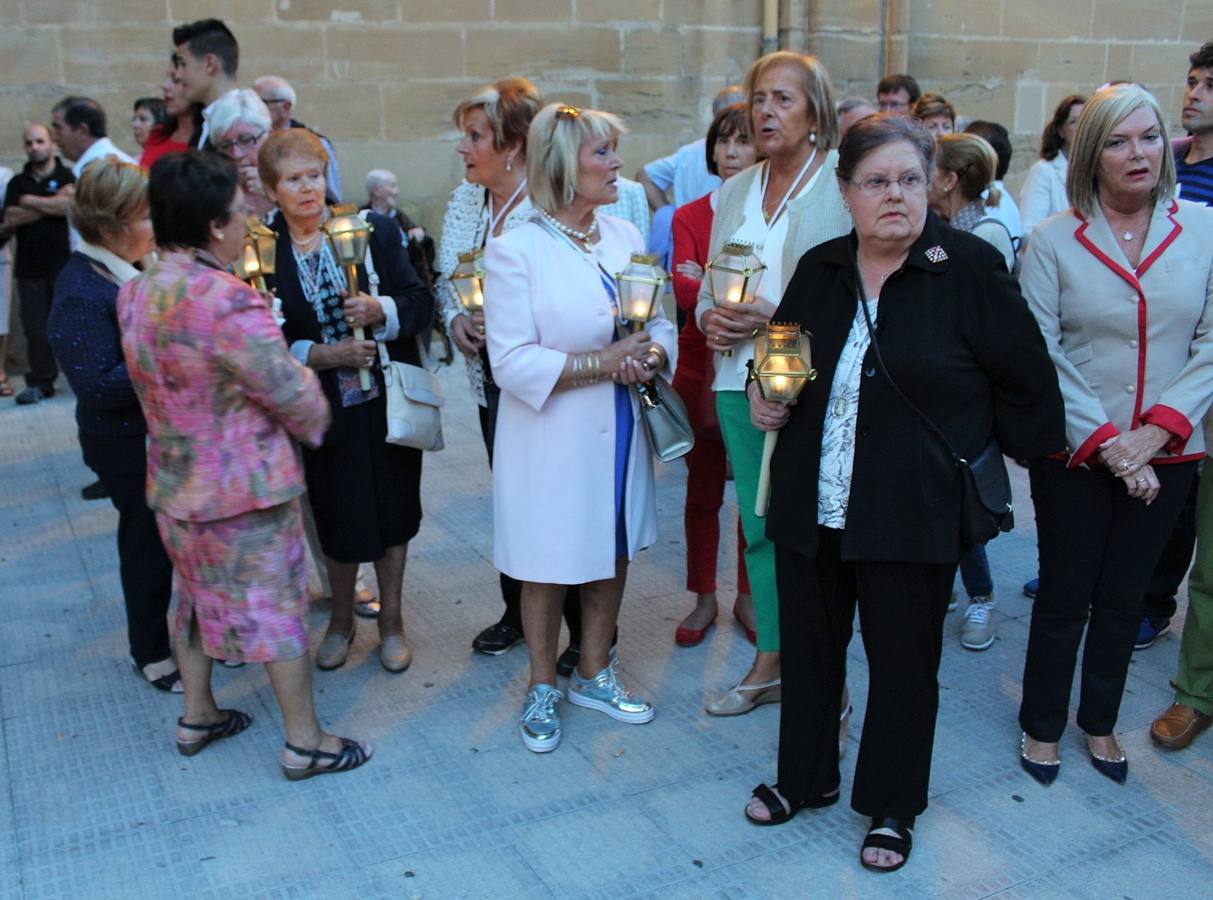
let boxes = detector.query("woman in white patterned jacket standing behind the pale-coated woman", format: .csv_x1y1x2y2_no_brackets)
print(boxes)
437,78,594,674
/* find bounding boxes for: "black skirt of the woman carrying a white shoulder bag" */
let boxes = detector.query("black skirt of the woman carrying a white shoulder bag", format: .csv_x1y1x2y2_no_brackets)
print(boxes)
303,385,421,563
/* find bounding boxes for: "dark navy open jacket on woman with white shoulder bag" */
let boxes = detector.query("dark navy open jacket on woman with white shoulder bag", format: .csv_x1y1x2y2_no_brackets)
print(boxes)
272,212,434,445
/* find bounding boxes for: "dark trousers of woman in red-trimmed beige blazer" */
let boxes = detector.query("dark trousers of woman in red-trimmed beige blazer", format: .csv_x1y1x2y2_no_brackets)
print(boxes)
1019,460,1196,744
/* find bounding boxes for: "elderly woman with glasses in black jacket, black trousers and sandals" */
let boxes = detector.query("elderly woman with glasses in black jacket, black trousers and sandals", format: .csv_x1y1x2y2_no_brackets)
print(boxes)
746,115,1065,871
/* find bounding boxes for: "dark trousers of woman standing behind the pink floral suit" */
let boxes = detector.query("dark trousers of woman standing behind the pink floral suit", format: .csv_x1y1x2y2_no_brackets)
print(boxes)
80,434,172,668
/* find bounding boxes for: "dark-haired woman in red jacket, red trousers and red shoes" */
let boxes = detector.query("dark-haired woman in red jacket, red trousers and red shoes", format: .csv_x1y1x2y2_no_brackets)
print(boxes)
673,103,758,646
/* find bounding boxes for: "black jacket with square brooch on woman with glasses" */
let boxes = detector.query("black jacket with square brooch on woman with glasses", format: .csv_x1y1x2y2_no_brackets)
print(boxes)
767,213,1065,564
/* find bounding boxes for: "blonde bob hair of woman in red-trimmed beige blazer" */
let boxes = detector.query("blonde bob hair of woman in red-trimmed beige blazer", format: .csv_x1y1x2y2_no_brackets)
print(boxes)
1065,84,1175,218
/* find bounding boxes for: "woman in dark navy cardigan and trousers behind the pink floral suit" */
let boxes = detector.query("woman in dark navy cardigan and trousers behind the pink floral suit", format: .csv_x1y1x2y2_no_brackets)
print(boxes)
47,156,181,694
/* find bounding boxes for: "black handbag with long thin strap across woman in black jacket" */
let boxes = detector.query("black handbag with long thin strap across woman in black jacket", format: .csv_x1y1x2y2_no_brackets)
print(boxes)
855,272,1015,549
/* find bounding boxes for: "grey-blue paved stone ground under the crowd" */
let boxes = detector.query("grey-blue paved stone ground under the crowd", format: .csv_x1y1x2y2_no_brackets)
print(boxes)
0,364,1213,900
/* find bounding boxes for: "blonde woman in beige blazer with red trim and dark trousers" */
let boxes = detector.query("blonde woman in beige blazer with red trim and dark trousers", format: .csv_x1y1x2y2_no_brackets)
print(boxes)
1019,84,1213,784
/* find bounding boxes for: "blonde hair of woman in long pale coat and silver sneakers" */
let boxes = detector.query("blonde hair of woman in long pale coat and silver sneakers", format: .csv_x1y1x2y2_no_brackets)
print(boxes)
526,103,627,213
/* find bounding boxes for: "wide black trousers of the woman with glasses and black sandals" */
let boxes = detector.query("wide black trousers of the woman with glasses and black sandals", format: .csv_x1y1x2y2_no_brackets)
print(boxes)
775,528,956,819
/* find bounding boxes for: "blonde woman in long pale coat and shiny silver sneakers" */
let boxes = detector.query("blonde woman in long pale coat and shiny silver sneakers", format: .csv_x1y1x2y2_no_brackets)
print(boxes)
485,104,677,753
